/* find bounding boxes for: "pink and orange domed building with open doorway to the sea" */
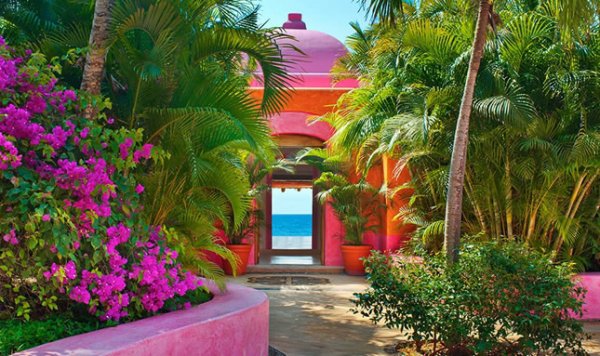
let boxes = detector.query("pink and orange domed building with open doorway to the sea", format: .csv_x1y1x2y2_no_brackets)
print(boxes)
249,13,408,272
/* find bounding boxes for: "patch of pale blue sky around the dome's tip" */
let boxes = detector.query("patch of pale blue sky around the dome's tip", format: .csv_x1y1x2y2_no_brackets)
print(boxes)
256,0,367,42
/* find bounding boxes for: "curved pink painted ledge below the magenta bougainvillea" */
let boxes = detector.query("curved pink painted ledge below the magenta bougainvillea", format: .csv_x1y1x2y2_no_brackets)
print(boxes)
15,284,269,356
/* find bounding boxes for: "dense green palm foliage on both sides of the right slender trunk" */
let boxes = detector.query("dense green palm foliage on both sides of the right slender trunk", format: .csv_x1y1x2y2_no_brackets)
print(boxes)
324,0,600,268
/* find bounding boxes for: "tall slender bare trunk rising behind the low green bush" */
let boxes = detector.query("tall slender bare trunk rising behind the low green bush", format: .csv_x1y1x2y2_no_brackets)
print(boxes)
444,0,490,264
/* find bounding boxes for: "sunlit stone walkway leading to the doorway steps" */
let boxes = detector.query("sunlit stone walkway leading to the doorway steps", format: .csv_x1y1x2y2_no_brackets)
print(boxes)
230,274,600,356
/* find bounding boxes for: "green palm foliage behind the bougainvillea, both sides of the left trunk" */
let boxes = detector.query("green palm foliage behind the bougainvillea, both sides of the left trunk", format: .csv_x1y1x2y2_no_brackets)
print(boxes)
0,0,296,278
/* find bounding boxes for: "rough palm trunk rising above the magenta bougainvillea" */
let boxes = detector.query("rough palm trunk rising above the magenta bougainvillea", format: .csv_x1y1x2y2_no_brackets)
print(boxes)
81,0,115,96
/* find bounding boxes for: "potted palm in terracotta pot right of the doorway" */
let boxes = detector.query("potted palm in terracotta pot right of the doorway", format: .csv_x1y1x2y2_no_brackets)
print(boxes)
315,172,378,276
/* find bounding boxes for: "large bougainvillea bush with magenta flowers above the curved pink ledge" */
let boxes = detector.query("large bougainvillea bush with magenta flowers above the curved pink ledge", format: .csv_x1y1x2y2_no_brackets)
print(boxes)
0,38,201,320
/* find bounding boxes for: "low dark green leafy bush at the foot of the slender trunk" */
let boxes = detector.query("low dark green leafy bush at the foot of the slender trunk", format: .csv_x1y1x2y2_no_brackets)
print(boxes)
353,243,585,354
